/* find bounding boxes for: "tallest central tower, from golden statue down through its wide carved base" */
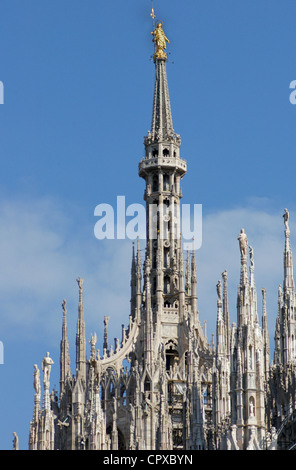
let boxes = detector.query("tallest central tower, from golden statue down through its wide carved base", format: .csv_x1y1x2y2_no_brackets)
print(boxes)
132,18,212,449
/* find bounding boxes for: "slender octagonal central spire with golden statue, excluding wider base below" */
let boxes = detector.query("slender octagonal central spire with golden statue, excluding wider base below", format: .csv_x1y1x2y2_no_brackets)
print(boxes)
139,23,190,338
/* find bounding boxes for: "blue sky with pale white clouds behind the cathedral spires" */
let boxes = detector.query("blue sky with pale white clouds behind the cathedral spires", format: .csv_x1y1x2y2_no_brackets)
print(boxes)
0,0,296,449
